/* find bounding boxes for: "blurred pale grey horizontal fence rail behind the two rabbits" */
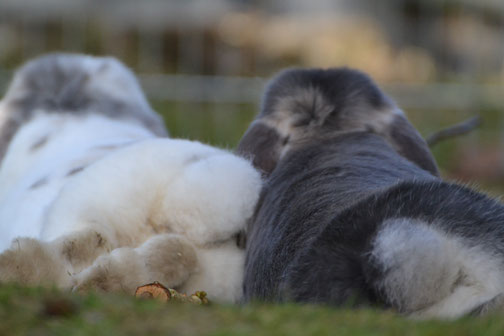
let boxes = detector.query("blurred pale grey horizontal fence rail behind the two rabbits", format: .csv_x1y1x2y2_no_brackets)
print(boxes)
0,71,504,113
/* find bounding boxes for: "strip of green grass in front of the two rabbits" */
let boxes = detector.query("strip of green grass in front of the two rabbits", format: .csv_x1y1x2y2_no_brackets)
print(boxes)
0,285,504,336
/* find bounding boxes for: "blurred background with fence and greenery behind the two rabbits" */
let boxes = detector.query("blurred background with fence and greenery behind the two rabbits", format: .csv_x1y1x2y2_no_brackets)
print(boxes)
0,0,504,195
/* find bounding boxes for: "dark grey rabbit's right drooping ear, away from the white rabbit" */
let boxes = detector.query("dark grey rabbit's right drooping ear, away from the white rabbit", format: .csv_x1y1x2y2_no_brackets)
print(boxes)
385,114,439,176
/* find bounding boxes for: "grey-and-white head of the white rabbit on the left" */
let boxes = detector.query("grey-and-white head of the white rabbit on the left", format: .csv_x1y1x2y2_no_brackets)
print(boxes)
0,54,167,165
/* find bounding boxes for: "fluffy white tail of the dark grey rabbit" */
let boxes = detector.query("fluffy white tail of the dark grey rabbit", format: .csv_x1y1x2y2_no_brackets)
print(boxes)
373,218,504,318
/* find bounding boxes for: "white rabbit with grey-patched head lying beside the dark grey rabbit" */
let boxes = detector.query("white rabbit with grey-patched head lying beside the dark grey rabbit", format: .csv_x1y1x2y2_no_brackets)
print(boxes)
0,55,261,301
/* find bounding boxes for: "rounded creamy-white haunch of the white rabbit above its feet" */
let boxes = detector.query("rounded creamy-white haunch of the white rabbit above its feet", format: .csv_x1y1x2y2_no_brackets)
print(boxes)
41,139,260,244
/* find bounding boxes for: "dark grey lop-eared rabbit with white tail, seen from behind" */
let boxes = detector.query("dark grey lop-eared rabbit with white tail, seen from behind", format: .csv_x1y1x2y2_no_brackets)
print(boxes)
238,69,504,318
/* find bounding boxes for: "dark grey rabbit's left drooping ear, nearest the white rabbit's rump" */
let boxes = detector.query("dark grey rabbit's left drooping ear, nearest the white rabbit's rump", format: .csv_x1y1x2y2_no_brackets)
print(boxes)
235,120,282,175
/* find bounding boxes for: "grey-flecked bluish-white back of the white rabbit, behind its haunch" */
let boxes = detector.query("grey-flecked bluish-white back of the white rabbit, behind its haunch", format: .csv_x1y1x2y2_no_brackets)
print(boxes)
0,114,153,247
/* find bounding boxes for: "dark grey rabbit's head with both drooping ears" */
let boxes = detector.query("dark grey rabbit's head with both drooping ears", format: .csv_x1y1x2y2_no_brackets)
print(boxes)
237,68,439,175
